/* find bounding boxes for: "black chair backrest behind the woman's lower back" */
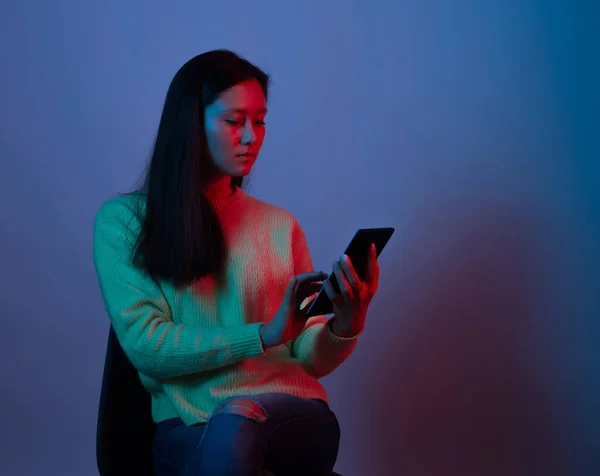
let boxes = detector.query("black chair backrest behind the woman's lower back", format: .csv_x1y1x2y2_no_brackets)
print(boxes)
96,326,156,476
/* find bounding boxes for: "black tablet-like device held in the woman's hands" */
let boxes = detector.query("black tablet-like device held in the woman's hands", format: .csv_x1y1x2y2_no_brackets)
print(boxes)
306,227,395,317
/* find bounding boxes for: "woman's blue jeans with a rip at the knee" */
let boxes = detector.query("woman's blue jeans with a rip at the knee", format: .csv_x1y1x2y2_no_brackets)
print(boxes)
153,393,340,476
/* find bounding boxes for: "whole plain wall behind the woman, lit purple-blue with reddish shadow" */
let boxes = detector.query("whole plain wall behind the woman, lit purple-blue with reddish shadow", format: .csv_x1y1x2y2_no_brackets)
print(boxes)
0,0,600,476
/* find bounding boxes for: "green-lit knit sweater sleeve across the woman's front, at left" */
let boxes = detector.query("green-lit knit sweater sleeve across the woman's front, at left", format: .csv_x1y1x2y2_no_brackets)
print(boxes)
94,199,264,379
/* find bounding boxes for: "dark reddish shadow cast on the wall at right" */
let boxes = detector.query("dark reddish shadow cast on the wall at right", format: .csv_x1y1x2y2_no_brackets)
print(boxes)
350,201,567,476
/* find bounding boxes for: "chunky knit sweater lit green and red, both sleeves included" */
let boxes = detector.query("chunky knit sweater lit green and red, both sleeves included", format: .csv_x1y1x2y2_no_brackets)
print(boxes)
94,187,357,425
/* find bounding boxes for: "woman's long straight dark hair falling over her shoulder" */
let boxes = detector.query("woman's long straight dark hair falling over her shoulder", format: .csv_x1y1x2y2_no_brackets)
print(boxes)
133,50,269,287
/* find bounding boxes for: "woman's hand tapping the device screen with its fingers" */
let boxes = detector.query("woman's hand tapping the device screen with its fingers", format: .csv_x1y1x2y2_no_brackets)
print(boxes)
260,271,328,348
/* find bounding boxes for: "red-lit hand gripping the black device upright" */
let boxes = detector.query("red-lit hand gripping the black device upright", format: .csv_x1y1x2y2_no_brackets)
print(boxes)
323,245,379,338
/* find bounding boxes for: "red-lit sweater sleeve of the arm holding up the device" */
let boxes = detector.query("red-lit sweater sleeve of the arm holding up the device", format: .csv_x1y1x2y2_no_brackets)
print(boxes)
289,221,358,378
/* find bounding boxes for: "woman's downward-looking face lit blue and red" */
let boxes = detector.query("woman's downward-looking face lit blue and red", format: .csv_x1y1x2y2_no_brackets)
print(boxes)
204,79,267,177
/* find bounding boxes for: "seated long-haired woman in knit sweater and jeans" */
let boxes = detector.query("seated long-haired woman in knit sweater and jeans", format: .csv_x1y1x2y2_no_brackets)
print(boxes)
94,50,379,476
